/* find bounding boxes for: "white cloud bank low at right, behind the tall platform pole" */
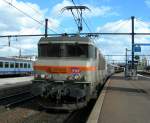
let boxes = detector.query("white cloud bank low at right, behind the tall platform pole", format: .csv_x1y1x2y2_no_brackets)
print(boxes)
96,20,150,60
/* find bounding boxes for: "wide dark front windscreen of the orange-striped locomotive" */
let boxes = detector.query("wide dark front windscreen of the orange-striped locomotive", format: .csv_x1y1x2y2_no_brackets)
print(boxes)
39,43,96,58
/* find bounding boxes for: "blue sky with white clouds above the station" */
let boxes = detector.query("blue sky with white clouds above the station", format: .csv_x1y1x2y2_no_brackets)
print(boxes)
0,0,150,60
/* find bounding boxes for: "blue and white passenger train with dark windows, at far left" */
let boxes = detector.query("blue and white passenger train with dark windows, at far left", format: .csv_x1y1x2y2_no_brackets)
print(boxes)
0,57,33,76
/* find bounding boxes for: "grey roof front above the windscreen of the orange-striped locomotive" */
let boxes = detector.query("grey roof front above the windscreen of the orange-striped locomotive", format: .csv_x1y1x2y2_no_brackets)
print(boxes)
39,35,91,44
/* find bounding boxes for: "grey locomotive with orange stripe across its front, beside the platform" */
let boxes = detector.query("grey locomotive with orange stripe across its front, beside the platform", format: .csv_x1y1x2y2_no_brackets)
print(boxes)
32,35,114,110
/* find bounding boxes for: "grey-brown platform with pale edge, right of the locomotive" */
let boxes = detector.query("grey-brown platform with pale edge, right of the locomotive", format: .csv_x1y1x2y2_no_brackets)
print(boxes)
87,73,150,123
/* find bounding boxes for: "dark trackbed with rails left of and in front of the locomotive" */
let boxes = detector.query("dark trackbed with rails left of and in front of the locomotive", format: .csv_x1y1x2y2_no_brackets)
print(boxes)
0,87,96,123
